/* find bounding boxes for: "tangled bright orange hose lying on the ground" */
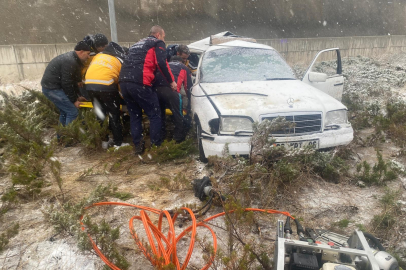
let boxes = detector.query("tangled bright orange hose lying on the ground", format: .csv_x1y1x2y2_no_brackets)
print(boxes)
80,202,294,270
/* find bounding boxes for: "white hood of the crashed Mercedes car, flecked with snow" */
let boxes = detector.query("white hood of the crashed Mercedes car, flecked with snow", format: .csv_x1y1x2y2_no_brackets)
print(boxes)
200,80,346,121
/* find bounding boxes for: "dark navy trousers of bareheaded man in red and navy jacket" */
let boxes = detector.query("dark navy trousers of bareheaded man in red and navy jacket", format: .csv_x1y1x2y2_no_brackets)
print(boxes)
120,82,161,146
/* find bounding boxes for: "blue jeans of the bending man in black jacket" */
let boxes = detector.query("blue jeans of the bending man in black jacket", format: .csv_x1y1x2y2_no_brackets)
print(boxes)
42,88,79,126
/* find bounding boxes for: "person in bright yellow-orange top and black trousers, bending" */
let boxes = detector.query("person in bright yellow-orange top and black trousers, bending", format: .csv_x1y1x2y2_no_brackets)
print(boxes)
85,42,125,146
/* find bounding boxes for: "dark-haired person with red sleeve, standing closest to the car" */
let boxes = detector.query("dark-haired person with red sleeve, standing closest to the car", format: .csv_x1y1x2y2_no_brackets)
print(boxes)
154,55,192,143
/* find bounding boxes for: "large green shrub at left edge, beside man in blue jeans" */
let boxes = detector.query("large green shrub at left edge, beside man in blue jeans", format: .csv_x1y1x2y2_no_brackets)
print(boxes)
0,91,62,200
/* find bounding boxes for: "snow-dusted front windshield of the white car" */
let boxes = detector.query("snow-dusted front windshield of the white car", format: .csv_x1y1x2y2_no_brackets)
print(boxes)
200,48,295,83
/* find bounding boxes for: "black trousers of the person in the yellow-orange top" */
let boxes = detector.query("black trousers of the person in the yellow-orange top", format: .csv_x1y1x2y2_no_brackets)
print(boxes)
87,90,123,146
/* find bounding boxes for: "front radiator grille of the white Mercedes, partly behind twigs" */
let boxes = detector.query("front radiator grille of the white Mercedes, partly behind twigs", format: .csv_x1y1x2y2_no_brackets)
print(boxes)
262,113,321,136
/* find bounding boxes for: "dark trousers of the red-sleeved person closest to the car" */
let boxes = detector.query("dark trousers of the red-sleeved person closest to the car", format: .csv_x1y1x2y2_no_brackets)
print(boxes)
155,86,186,142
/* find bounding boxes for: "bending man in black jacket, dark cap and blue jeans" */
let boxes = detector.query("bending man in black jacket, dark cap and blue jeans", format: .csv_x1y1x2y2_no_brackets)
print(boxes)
41,41,90,126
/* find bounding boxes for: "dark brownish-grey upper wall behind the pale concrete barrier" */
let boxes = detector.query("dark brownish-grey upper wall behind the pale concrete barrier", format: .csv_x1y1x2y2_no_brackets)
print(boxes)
0,0,406,45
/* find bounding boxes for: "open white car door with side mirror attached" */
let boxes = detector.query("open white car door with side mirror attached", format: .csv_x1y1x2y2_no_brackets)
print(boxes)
302,48,344,101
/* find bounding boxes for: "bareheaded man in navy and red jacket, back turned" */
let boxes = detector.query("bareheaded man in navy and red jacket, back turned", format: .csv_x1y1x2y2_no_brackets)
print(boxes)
119,25,177,154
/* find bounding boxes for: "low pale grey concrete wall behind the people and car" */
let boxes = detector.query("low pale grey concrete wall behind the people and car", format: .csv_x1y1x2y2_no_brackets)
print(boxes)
0,36,406,84
